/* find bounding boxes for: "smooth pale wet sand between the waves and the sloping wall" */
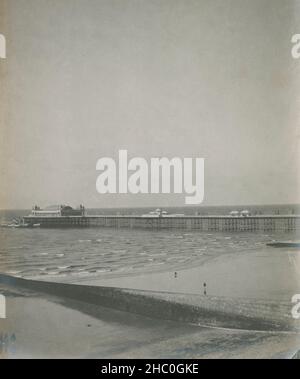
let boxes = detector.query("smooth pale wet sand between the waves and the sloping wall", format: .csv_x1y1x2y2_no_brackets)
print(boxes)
63,248,300,302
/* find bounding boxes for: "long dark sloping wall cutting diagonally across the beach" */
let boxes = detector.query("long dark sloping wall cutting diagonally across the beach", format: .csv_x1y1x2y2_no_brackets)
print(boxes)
0,274,299,332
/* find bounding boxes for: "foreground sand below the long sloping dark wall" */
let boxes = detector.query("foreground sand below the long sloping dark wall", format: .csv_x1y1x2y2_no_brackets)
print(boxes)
0,277,300,358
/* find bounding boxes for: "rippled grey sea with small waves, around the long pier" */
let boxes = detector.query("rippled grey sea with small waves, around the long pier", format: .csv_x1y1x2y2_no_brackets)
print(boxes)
0,207,294,280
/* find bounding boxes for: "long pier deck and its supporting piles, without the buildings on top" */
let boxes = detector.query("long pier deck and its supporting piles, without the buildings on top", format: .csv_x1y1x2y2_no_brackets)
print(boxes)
24,215,300,232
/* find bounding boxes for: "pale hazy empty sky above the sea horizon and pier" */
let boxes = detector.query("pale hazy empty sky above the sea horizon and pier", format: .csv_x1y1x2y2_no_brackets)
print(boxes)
0,0,300,209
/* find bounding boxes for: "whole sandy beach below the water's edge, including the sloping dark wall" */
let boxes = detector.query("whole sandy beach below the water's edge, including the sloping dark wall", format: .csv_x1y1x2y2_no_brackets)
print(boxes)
0,248,300,358
